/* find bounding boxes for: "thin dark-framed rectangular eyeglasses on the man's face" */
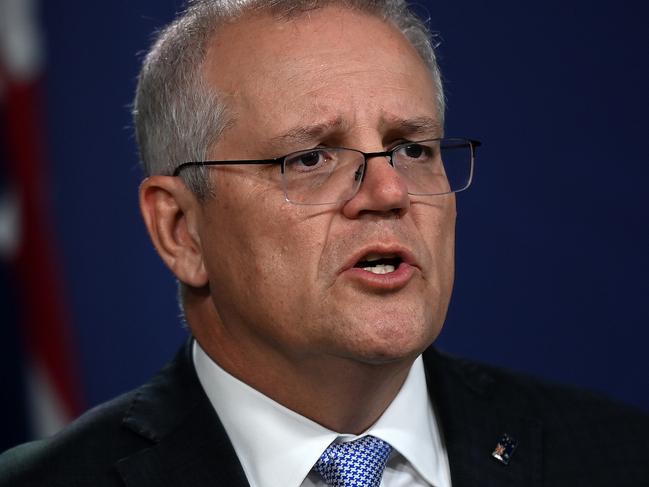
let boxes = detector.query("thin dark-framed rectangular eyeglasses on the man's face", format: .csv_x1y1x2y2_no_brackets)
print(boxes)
173,138,481,205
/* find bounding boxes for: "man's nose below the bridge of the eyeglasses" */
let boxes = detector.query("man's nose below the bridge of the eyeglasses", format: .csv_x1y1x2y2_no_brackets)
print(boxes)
343,156,410,218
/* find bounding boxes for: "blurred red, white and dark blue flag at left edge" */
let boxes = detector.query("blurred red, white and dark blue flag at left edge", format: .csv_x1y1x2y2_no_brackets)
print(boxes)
0,0,83,448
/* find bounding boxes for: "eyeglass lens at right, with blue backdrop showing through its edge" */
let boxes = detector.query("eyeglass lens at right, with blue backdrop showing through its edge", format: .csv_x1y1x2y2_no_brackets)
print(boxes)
393,139,473,195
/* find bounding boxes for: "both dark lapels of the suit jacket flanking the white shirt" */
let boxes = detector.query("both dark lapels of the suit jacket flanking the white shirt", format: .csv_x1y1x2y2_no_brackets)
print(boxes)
116,339,542,487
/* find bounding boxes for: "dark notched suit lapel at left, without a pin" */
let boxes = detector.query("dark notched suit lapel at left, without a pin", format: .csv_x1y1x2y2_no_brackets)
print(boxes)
116,341,249,487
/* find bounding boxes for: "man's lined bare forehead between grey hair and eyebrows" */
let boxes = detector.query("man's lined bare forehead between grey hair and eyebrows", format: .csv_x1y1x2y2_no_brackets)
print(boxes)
204,7,437,150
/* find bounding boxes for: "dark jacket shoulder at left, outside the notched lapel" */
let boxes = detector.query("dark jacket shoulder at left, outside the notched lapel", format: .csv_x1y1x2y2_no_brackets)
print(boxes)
0,392,146,487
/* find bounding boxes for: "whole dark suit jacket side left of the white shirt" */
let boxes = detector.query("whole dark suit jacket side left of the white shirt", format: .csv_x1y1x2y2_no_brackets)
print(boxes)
0,344,240,487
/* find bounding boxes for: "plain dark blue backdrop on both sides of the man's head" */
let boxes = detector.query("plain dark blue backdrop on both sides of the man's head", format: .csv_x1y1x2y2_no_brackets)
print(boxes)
26,0,649,428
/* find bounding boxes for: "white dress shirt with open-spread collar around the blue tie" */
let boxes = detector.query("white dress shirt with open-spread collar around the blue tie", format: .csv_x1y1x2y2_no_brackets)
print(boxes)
193,341,451,487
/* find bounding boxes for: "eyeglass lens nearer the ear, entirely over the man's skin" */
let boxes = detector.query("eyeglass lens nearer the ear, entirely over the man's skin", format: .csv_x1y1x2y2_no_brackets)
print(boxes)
283,148,364,205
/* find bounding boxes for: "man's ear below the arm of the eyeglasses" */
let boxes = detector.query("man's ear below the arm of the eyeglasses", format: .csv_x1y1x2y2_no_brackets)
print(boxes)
140,176,208,287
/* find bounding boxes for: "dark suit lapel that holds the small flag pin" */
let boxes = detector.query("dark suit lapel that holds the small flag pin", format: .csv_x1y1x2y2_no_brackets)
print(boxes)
424,349,542,487
